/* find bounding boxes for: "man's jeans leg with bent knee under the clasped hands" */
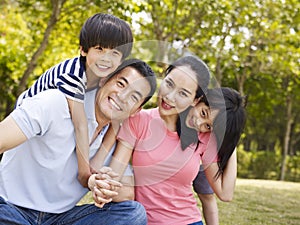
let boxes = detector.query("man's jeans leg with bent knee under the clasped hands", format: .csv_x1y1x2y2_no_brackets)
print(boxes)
54,201,147,225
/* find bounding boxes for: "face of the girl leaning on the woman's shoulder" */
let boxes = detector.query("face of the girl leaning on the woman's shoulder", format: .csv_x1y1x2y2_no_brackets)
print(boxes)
185,102,219,133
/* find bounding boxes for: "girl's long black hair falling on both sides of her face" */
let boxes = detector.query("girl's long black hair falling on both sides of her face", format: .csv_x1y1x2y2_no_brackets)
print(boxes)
176,87,246,178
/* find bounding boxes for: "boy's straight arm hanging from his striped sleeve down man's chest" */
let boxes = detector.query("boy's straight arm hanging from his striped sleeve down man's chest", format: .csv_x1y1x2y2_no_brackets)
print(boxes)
67,98,91,187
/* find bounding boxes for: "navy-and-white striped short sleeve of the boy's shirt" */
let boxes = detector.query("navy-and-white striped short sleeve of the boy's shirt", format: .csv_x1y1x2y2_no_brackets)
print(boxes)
56,73,86,103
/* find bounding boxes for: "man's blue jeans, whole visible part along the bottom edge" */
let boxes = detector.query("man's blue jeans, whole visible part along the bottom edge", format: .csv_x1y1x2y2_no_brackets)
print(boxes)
0,197,147,225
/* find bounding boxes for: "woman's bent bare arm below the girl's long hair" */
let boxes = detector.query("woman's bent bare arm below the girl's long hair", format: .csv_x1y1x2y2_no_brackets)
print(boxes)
205,149,237,202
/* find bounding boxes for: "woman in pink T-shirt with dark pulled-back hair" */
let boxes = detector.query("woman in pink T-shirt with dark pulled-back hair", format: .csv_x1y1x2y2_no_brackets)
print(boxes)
111,56,211,225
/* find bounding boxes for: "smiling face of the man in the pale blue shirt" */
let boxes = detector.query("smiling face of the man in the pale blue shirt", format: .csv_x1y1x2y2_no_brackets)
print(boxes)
95,66,150,120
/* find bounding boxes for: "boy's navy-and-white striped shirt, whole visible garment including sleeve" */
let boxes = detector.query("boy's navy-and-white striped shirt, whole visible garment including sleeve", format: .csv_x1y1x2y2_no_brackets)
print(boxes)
17,57,87,106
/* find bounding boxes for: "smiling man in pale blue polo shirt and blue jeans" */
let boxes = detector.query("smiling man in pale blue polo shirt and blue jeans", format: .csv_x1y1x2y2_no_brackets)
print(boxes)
0,60,156,224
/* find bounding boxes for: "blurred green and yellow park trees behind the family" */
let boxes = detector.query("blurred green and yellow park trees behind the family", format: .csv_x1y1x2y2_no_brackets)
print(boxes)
0,0,300,185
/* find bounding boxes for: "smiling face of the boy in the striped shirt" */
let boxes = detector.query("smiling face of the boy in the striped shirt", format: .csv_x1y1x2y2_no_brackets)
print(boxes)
81,46,123,78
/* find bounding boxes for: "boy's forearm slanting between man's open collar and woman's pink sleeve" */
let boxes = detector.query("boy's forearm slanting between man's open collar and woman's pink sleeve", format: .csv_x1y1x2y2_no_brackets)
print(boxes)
90,122,120,173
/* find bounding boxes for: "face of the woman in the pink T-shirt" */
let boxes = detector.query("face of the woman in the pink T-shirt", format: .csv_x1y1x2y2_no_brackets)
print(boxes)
158,66,198,116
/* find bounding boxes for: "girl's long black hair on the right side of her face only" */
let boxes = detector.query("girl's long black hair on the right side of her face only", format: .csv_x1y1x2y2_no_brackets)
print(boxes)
207,87,246,177
